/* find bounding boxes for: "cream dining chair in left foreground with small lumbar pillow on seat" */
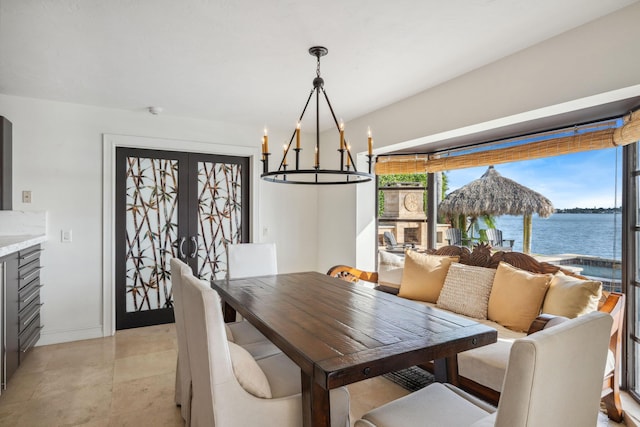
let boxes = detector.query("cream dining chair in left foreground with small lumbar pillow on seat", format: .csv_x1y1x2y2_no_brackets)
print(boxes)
182,270,349,427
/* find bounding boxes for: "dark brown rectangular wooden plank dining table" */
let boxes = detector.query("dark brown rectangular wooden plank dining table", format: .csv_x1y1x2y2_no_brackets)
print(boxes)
211,272,497,427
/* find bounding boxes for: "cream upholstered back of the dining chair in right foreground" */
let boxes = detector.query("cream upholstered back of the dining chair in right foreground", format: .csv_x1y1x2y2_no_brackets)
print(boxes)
495,311,613,427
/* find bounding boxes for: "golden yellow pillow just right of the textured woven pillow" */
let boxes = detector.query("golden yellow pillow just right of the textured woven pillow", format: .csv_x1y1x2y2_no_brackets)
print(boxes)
487,262,552,332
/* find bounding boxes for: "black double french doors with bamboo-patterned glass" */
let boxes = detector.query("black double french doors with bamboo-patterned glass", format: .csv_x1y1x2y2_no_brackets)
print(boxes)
115,148,249,329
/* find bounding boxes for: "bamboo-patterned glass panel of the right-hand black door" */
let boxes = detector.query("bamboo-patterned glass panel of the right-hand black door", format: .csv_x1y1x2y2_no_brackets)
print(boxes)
197,162,243,280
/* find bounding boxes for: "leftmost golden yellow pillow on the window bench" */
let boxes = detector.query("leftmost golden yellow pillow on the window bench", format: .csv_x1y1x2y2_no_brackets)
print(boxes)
398,251,460,302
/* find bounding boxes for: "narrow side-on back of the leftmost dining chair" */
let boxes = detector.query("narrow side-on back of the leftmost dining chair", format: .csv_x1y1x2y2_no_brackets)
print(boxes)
170,258,192,426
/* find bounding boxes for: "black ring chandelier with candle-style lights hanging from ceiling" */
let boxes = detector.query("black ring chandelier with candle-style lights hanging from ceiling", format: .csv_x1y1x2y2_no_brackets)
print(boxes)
260,46,373,185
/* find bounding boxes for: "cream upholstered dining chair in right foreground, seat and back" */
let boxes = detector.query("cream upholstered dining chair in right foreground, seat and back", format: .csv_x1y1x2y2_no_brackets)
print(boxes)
355,311,613,427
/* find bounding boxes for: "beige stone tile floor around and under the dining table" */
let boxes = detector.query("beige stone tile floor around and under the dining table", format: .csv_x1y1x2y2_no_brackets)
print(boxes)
0,325,632,427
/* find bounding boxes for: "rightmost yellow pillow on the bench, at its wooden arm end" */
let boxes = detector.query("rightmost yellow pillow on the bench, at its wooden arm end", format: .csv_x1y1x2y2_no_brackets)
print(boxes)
542,271,602,319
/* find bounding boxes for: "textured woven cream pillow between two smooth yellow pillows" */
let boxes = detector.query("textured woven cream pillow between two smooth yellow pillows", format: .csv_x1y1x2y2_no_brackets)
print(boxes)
437,262,496,319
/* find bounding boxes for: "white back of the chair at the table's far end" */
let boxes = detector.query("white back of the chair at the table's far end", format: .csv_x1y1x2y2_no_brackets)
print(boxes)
227,243,278,279
